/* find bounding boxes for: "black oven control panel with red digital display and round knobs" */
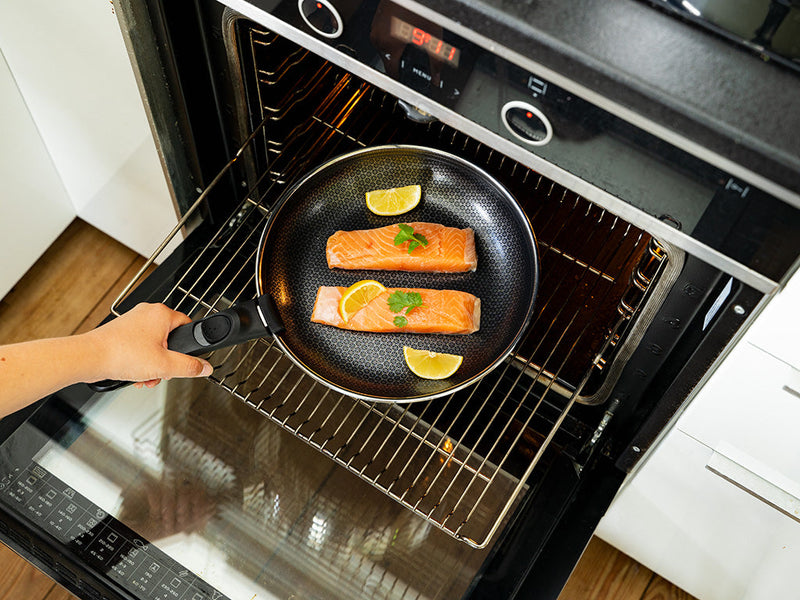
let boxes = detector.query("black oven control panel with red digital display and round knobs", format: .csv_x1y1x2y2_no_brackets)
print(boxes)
253,0,800,279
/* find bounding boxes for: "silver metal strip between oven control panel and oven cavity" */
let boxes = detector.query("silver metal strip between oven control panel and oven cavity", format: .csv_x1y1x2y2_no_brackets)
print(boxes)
212,0,780,294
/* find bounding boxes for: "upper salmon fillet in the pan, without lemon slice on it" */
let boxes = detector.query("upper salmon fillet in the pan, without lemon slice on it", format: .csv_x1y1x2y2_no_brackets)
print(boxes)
325,223,478,273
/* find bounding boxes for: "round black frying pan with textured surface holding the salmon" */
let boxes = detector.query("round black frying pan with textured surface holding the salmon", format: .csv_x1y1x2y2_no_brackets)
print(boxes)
97,146,539,403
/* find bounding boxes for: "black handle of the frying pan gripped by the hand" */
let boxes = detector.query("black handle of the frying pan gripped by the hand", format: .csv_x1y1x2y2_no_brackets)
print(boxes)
89,296,284,392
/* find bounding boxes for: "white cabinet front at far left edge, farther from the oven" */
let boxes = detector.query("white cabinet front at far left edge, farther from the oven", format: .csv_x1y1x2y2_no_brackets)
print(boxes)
0,53,75,298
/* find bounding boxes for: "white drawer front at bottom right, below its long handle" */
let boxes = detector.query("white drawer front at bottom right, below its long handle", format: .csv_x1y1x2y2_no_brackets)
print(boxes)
597,430,800,600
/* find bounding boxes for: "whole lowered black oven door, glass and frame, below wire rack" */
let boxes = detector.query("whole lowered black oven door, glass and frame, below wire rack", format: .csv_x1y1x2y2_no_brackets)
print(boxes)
0,227,622,600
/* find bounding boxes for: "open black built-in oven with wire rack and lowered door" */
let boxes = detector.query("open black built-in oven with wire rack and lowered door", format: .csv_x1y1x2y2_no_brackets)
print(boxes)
0,0,800,599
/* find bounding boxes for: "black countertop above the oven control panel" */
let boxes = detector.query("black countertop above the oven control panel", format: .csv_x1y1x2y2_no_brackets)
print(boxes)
410,0,800,206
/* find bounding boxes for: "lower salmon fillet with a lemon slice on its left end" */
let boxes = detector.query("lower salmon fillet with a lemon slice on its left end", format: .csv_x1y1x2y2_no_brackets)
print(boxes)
311,286,481,334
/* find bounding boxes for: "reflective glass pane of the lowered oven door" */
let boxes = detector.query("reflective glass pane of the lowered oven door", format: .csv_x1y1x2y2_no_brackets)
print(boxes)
0,380,488,600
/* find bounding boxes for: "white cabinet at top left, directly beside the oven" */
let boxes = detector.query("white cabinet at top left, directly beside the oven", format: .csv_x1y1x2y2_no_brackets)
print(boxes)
0,0,177,264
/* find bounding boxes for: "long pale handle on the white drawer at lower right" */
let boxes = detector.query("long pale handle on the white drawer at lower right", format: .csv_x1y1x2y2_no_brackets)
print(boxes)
706,442,800,523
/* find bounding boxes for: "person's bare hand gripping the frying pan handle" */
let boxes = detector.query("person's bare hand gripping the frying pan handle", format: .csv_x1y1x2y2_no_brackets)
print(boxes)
84,303,213,387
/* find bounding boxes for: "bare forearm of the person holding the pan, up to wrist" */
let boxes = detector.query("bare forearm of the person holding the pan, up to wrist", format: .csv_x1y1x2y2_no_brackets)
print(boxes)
0,334,103,416
